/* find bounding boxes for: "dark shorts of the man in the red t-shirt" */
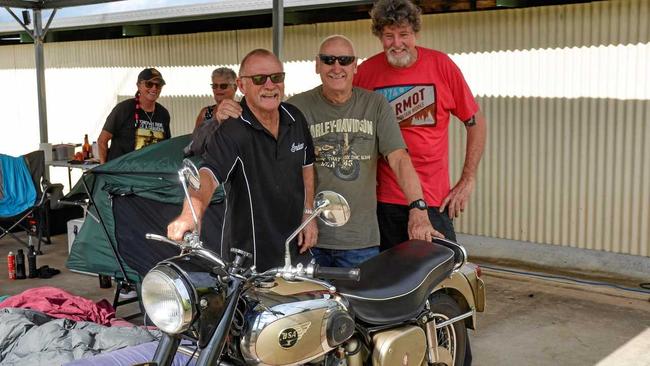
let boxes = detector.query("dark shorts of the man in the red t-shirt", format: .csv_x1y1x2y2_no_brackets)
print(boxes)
377,202,456,251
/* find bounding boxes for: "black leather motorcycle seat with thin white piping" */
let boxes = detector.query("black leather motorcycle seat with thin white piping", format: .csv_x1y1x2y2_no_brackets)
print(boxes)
333,240,454,325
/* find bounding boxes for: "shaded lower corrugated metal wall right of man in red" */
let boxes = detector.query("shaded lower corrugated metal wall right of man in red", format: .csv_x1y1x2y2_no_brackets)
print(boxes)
450,97,650,256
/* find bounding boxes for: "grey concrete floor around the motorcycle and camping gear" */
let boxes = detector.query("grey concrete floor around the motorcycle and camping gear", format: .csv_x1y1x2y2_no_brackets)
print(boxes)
0,235,650,366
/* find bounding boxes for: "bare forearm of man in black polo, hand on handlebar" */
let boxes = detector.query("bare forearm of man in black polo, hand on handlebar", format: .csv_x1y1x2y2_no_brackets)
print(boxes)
167,169,219,241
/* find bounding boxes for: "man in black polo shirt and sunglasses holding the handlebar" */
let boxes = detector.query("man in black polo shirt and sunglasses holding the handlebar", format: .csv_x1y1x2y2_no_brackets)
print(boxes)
167,49,318,271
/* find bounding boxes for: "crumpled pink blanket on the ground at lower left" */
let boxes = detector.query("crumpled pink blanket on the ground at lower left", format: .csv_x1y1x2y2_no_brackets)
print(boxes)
0,286,120,326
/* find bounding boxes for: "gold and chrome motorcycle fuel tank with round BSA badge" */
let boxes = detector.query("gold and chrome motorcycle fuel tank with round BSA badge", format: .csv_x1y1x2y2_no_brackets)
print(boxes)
240,279,354,365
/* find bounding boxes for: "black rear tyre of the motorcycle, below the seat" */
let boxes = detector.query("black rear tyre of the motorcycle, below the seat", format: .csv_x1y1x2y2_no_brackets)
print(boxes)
429,292,467,366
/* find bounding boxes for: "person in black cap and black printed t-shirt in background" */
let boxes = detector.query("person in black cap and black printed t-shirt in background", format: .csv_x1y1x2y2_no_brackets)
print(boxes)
97,68,171,164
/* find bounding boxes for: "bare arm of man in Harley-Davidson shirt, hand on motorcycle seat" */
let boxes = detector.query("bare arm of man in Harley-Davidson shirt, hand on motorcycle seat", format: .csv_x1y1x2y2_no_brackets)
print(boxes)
386,149,444,241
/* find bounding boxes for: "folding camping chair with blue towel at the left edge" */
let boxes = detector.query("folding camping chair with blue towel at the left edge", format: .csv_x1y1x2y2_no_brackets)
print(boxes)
0,150,63,254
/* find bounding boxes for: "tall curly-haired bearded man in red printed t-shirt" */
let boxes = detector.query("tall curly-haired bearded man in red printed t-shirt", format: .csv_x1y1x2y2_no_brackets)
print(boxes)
354,0,487,250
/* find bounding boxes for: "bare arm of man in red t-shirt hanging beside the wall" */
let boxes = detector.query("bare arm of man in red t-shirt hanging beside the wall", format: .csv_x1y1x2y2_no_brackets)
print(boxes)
440,111,487,218
